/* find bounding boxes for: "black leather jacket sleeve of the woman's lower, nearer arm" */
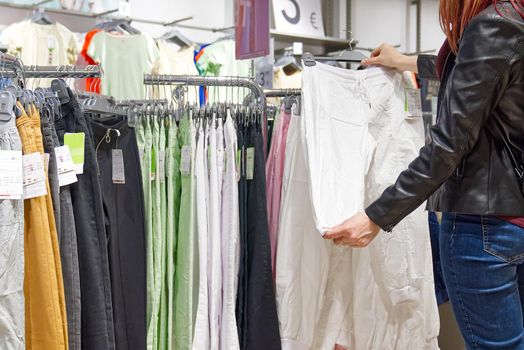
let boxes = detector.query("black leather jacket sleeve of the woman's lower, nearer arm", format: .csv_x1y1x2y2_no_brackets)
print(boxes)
366,15,521,231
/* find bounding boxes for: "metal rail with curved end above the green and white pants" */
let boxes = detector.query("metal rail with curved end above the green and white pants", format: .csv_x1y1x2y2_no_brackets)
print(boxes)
144,74,267,155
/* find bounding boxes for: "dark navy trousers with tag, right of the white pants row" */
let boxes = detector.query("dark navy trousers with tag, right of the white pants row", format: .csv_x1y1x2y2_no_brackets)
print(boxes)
237,124,281,350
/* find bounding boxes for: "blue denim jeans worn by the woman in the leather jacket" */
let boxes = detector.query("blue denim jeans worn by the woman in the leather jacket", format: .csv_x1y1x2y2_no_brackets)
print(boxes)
440,213,524,350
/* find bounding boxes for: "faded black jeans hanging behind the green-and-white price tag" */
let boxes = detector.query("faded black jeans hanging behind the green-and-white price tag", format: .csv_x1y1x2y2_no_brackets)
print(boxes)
55,89,115,350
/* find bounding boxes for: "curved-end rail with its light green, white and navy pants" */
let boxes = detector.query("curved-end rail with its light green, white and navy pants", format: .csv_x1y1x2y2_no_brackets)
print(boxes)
141,75,280,350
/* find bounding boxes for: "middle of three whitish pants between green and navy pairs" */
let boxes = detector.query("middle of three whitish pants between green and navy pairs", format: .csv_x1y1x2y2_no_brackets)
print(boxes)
205,118,222,350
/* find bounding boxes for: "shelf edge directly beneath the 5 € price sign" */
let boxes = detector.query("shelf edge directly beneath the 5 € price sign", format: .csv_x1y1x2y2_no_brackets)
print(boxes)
270,29,349,55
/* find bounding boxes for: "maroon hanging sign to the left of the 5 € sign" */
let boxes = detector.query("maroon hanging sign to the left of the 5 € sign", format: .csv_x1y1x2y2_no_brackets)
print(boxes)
235,0,269,60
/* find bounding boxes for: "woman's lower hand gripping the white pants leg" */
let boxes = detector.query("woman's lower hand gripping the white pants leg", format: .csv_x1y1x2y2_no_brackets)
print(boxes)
324,213,380,248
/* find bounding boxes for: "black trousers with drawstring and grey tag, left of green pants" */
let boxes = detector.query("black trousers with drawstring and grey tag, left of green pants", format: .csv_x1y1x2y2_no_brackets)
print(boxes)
87,116,146,350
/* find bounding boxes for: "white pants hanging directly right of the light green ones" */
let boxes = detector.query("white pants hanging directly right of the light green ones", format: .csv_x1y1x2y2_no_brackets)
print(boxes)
192,125,210,350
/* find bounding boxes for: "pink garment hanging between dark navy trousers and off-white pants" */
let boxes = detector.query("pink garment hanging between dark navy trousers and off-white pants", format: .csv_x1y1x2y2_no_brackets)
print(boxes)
266,108,291,279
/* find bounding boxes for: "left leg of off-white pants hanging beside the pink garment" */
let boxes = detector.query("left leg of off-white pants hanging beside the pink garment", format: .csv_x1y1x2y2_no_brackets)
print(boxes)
275,115,332,350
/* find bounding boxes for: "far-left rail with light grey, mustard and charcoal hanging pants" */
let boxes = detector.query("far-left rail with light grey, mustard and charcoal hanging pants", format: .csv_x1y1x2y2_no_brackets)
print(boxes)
0,62,109,349
